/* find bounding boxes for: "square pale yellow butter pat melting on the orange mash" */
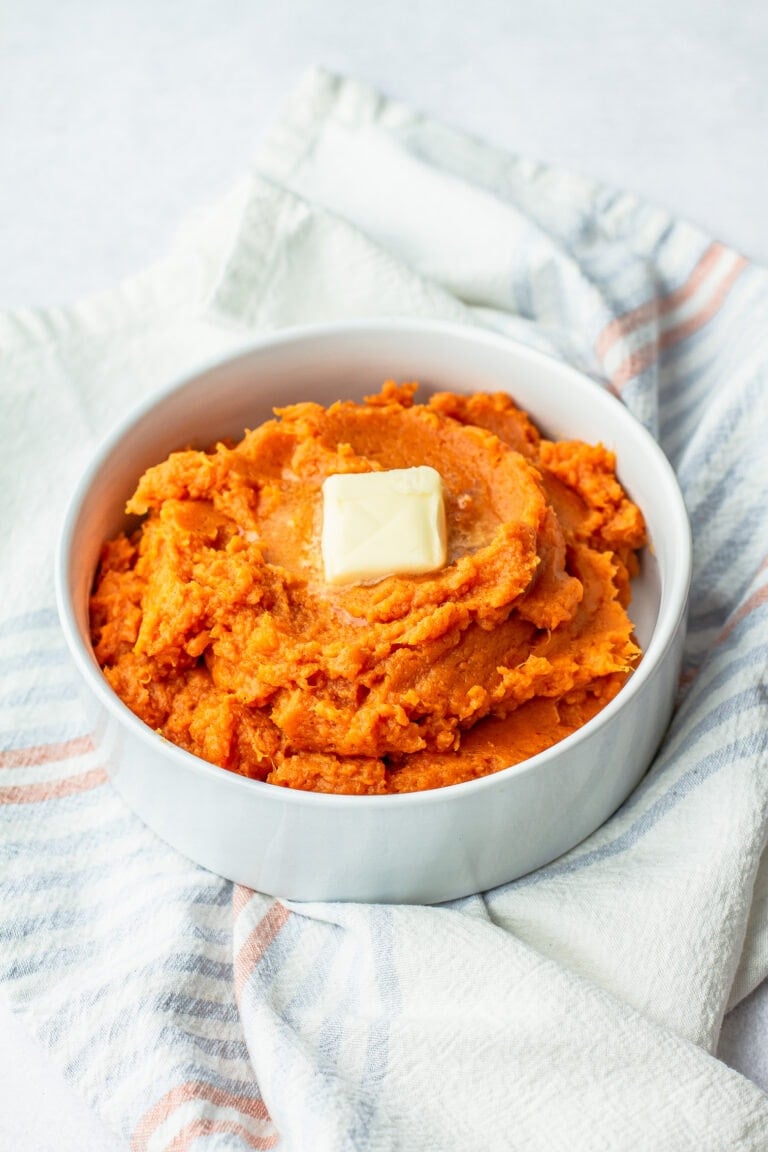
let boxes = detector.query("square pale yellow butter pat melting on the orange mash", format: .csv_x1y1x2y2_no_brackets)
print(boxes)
321,464,447,584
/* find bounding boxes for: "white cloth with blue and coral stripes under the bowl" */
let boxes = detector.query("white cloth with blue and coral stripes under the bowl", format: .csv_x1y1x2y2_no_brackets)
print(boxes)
0,73,768,1152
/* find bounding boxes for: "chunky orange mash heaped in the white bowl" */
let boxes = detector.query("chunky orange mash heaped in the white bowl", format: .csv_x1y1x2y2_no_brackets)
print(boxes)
91,381,646,794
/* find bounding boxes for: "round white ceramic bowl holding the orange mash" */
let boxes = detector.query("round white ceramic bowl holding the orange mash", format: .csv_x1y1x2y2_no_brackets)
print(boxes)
56,321,691,903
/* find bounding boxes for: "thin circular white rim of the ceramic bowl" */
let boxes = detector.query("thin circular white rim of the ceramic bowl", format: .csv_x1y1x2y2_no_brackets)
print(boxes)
54,317,692,811
